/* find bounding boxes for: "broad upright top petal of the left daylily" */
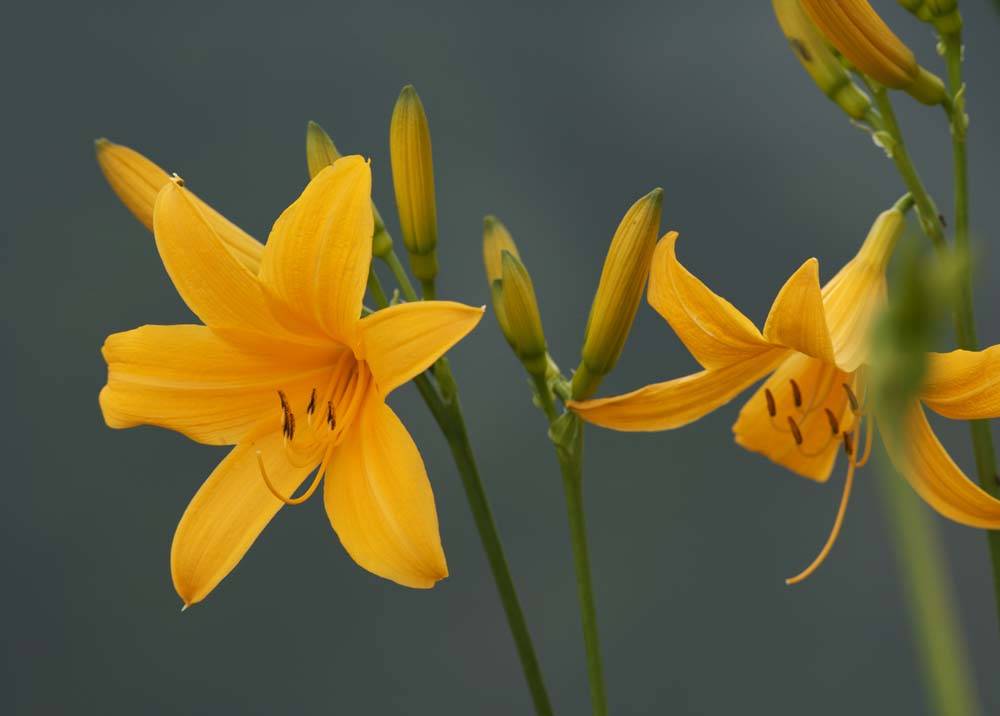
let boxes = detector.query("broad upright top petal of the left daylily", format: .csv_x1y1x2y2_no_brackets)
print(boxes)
260,155,374,345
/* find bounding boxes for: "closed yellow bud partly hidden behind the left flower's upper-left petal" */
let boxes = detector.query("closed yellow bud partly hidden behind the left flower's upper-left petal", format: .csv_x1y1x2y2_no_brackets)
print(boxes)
94,139,264,273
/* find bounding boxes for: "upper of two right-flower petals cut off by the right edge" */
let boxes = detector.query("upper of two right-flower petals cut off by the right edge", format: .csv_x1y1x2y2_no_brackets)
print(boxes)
920,346,1000,420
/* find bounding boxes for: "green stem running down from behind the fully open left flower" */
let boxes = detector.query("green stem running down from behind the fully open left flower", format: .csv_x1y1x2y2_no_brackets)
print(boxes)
368,262,553,716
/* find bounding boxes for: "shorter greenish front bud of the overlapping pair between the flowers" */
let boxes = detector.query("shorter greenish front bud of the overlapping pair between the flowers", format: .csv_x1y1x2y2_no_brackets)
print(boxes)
500,251,548,376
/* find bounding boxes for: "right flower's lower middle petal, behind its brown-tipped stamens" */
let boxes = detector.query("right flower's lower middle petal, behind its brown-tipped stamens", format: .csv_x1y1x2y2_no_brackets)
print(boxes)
733,353,854,482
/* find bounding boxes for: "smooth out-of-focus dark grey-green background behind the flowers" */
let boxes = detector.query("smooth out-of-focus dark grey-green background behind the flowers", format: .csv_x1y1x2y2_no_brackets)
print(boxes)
0,0,1000,714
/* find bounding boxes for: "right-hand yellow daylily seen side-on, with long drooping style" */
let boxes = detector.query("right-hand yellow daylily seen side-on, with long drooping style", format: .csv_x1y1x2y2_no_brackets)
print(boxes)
569,209,1000,583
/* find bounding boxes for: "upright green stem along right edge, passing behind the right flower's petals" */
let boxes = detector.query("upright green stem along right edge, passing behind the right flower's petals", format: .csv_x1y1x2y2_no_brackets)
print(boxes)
941,30,1000,628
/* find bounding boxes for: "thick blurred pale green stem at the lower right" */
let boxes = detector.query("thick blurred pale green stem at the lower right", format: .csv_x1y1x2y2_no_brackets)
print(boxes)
877,469,980,716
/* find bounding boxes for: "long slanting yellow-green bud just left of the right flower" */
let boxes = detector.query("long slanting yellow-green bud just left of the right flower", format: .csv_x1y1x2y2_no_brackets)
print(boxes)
573,189,663,400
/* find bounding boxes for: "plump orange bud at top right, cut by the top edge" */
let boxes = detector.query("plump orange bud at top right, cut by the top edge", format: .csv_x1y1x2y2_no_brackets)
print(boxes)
802,0,947,104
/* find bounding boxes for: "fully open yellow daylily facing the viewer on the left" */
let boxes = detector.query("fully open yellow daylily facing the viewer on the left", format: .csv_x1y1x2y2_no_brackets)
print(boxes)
100,156,482,605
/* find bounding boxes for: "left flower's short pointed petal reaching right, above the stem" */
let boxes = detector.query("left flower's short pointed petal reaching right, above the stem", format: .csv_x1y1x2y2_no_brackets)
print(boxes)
360,301,483,398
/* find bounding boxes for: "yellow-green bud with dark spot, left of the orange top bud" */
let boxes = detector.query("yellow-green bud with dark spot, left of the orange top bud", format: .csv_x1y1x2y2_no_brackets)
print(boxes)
771,0,871,119
